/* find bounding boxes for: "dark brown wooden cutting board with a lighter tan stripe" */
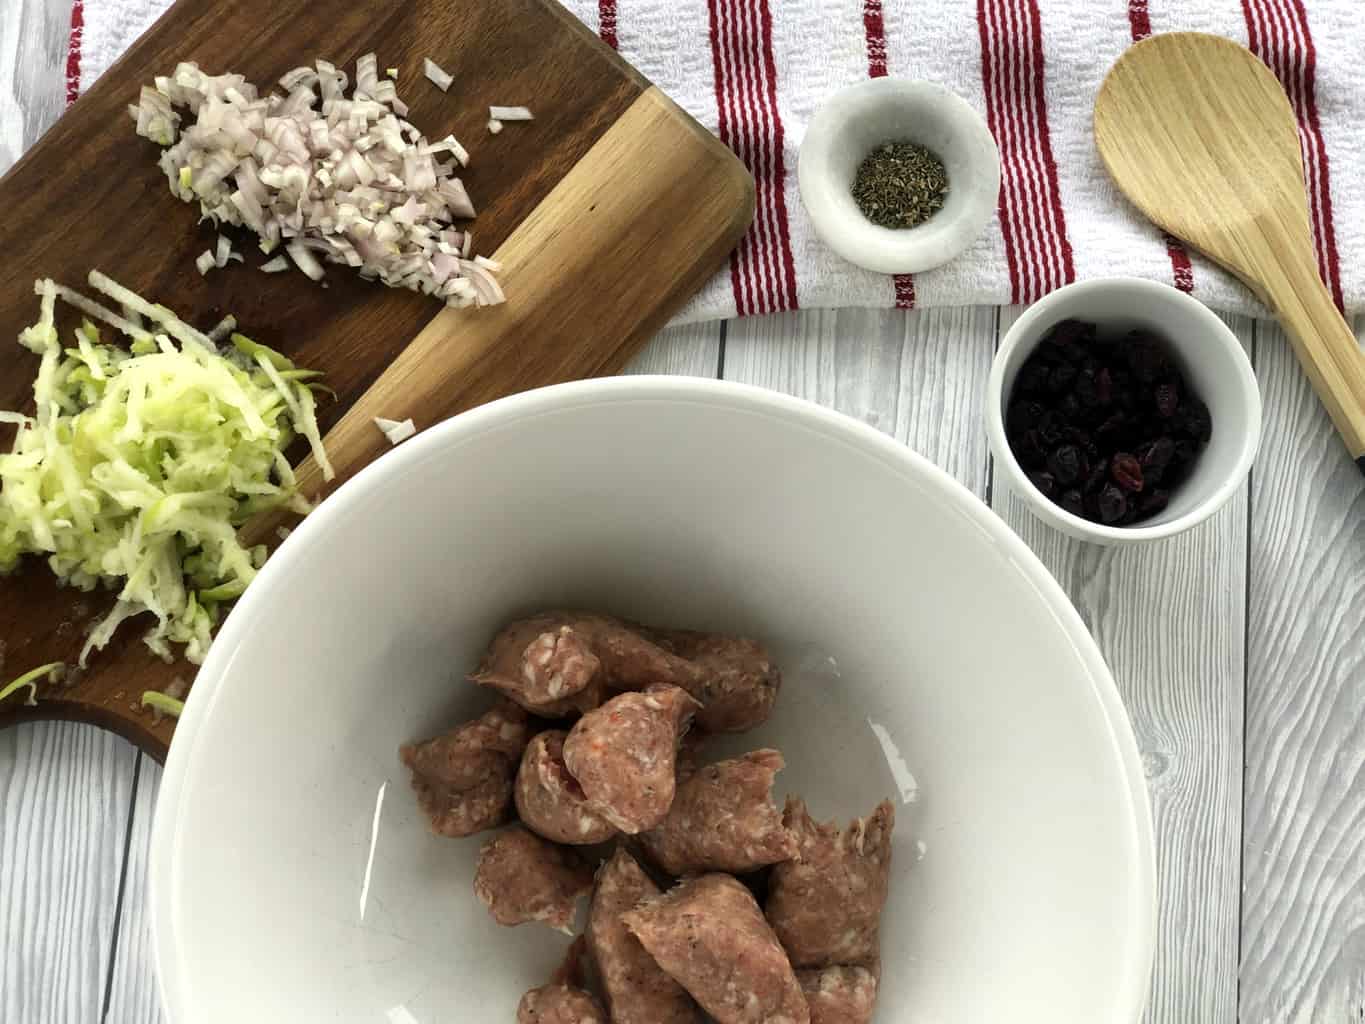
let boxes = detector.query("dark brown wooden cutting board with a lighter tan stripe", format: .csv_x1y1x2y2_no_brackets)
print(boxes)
0,0,753,759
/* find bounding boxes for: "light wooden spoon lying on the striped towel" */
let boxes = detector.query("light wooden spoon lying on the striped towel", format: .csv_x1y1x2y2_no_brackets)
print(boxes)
1095,31,1365,472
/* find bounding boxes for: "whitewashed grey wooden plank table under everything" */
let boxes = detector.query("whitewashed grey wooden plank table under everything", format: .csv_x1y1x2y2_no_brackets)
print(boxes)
0,0,1365,1024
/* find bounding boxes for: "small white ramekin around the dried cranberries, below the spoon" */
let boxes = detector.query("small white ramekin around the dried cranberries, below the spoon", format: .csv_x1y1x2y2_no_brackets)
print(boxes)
986,277,1261,545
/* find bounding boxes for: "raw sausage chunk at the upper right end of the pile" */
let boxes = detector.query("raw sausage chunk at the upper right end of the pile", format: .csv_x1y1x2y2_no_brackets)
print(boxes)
650,629,782,732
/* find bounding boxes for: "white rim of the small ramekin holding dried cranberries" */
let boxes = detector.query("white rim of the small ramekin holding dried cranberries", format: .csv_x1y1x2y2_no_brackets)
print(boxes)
986,277,1261,543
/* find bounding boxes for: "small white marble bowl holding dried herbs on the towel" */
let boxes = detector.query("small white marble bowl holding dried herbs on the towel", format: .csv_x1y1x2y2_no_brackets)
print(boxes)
797,78,1001,274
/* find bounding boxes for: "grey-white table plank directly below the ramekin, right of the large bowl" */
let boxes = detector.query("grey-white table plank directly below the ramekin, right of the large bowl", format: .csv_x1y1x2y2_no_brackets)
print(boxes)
991,309,1252,1024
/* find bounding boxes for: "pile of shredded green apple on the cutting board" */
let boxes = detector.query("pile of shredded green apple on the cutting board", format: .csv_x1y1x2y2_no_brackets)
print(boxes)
0,272,332,669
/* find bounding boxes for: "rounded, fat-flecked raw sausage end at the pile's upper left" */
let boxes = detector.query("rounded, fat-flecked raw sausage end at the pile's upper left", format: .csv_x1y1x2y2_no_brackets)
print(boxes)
470,616,602,718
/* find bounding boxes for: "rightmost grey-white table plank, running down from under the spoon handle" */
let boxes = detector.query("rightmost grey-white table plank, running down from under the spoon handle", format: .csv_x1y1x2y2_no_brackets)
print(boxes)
1241,318,1365,1024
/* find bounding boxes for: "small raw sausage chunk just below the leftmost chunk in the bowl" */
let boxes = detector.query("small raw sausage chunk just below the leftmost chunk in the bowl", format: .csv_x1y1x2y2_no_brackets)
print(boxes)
474,829,592,935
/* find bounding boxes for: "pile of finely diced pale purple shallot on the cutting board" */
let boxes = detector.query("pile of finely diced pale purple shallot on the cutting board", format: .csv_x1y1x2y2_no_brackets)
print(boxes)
128,53,504,306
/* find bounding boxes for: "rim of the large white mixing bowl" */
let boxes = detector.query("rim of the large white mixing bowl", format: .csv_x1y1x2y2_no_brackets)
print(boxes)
149,375,1156,1021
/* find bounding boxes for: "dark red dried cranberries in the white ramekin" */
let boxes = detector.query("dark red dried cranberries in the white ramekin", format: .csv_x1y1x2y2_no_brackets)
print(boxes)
1005,319,1213,526
